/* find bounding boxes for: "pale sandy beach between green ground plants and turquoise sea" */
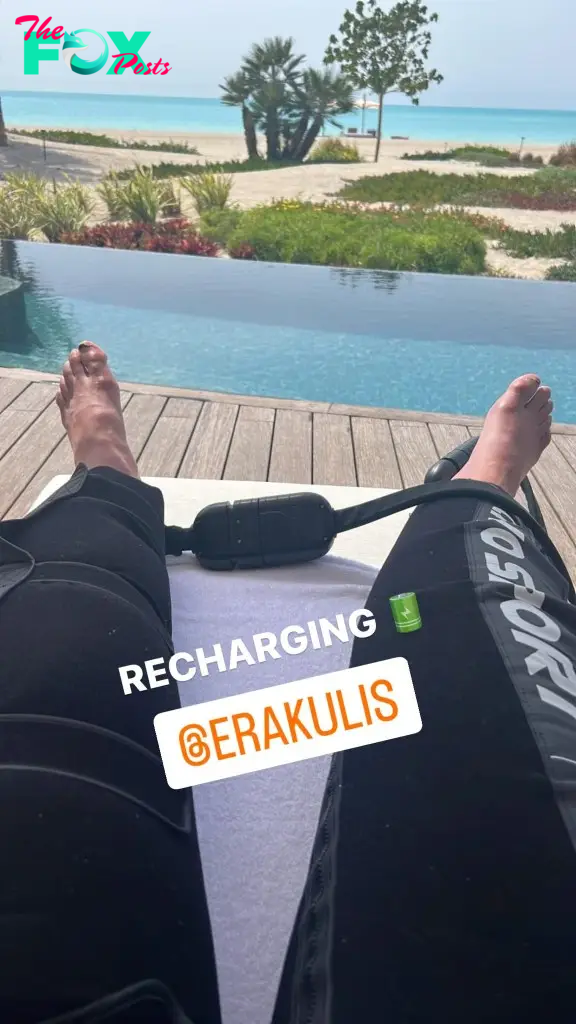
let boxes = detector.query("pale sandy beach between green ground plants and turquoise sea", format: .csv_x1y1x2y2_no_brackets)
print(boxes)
0,125,576,279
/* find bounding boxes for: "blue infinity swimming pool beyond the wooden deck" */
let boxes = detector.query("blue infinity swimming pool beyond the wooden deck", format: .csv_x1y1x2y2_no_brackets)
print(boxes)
0,242,576,423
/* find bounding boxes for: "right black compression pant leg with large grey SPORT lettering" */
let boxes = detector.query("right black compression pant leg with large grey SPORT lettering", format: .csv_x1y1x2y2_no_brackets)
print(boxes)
274,491,576,1024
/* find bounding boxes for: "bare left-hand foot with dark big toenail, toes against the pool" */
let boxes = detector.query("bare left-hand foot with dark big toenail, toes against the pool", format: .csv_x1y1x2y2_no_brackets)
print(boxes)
56,341,138,477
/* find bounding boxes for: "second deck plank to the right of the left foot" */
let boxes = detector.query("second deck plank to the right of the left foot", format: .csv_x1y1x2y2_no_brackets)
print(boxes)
138,398,202,476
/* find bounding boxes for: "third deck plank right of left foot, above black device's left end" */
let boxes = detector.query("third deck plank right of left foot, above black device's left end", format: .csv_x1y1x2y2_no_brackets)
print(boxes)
178,401,238,480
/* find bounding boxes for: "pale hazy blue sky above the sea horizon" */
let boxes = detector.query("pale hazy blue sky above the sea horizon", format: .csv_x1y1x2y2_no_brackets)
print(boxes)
0,0,576,110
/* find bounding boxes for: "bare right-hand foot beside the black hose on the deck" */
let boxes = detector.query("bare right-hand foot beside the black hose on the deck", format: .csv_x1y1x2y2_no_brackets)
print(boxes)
454,374,553,498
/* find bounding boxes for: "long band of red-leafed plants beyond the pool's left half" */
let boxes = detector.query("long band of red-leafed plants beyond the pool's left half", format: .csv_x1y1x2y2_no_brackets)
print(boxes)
61,217,218,256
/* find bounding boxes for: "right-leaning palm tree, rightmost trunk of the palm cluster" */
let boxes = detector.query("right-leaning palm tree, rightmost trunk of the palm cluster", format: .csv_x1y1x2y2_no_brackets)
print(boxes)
286,68,355,161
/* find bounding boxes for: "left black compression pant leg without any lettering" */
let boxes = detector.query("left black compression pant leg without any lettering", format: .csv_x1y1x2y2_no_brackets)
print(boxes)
0,468,219,1024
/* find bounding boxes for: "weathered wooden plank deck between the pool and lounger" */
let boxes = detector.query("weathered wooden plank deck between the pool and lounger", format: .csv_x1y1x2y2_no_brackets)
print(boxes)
0,368,576,579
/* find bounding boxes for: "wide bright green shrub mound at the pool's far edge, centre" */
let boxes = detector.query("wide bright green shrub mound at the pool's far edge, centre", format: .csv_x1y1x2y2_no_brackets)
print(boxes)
228,204,486,273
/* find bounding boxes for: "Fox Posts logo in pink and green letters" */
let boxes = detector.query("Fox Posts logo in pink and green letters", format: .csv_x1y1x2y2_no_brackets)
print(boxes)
14,14,171,75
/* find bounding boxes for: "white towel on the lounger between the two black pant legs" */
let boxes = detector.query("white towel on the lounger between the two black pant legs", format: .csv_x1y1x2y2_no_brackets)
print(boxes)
168,556,376,1024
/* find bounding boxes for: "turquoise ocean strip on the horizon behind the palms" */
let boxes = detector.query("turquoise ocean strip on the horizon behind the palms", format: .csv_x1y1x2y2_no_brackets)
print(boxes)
2,92,576,146
